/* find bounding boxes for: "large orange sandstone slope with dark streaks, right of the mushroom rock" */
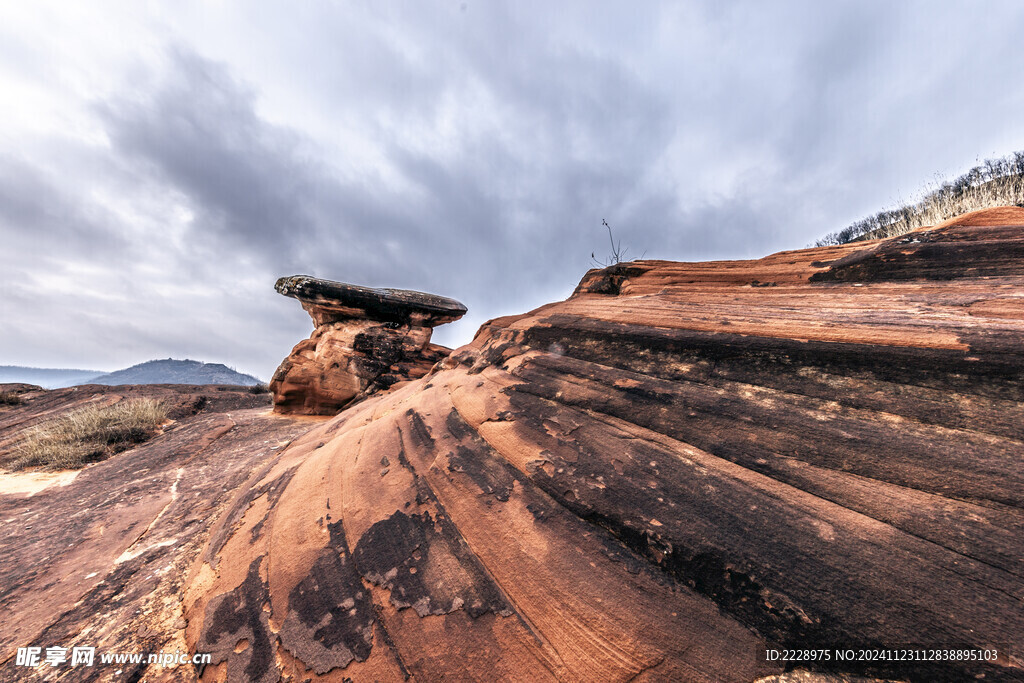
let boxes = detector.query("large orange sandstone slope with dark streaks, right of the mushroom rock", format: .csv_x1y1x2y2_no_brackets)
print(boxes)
184,209,1024,681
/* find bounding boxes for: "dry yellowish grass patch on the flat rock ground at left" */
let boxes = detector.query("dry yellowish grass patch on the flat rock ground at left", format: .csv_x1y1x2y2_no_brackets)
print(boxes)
7,398,167,470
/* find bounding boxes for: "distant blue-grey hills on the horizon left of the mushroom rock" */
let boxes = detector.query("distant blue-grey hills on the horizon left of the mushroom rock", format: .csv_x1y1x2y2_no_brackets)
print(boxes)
0,358,260,389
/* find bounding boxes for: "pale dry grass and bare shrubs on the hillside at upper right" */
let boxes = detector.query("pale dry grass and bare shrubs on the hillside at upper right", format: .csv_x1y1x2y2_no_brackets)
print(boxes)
814,152,1024,247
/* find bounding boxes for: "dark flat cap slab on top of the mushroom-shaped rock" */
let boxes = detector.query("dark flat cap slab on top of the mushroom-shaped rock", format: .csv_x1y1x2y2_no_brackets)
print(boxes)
274,275,467,327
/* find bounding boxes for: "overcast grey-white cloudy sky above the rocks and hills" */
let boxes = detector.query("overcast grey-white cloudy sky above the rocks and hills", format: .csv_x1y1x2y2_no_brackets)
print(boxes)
0,0,1024,379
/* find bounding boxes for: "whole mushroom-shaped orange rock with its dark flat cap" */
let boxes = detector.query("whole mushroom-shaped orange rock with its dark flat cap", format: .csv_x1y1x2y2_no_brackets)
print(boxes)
270,275,466,415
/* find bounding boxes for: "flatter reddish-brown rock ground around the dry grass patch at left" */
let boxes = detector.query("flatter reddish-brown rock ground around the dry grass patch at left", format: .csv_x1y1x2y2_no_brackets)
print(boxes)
0,385,310,683
